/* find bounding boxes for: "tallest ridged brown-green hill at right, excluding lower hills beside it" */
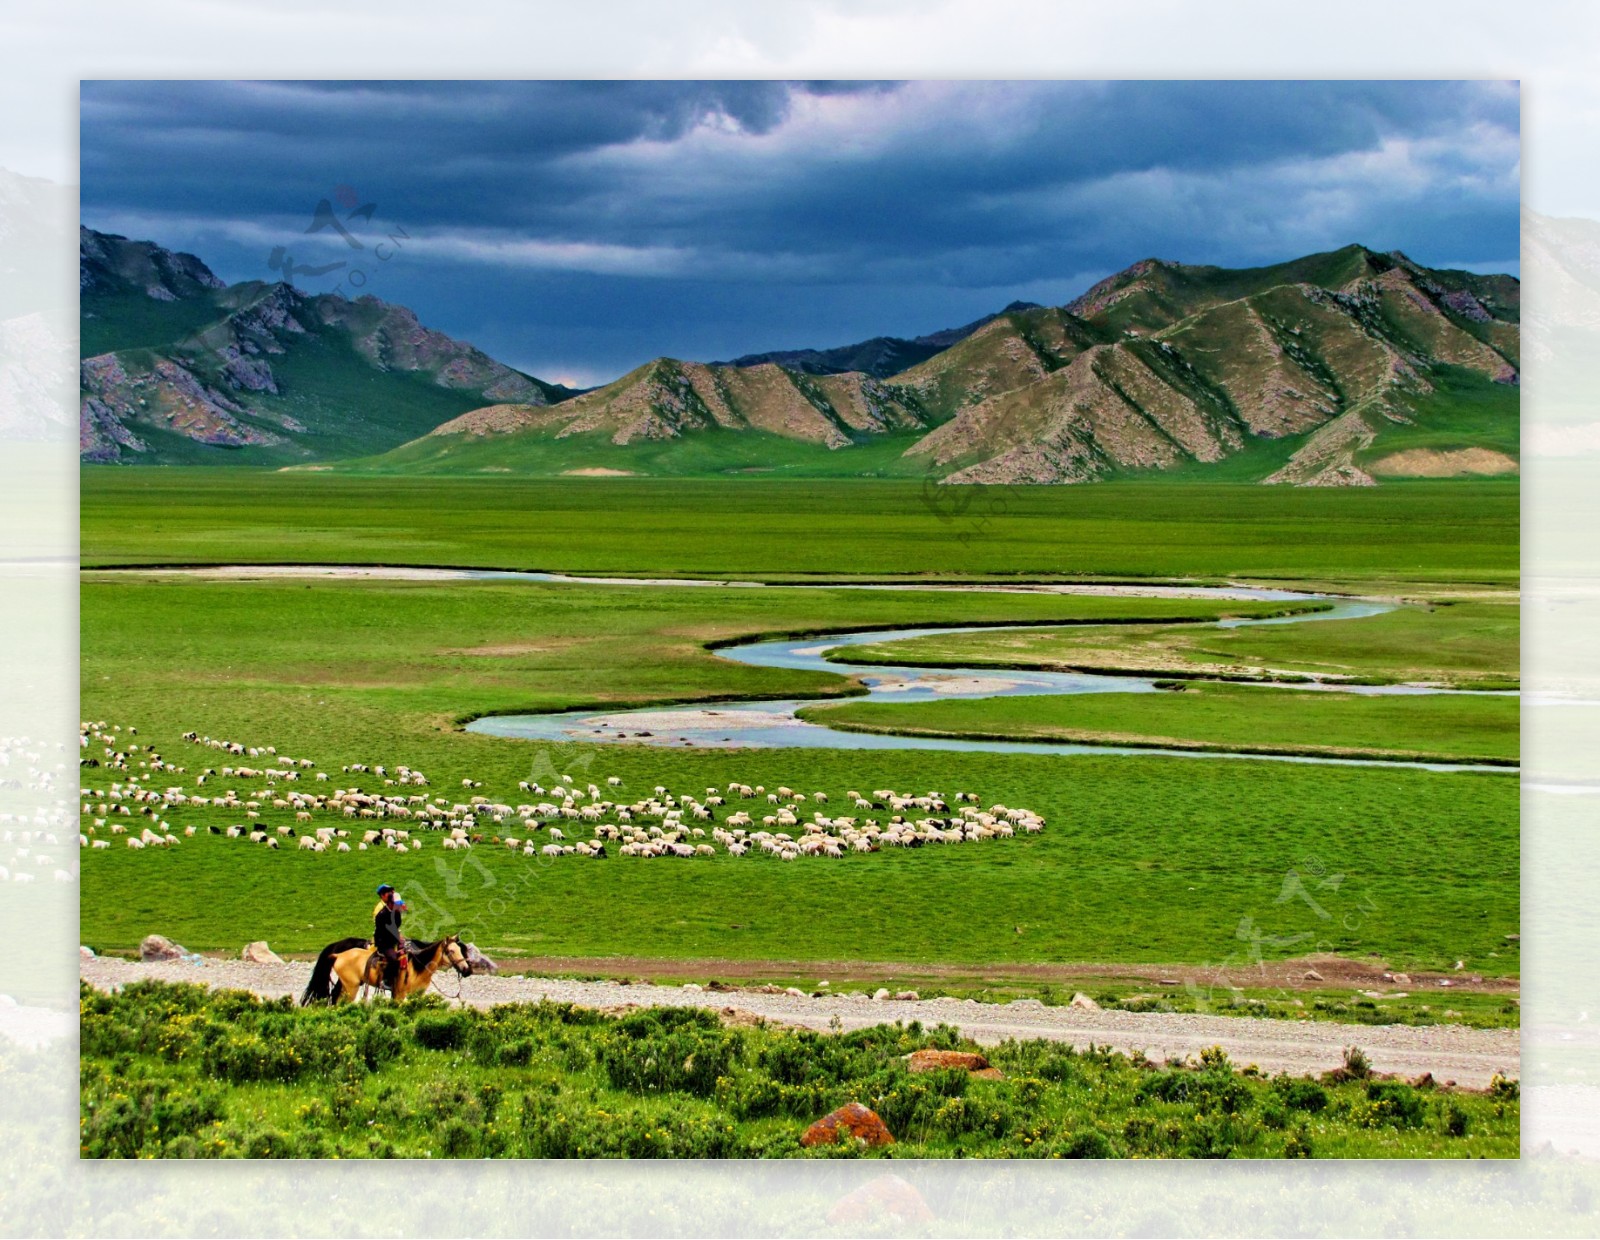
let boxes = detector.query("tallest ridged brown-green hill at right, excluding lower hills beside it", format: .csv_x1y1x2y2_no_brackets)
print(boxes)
894,246,1520,485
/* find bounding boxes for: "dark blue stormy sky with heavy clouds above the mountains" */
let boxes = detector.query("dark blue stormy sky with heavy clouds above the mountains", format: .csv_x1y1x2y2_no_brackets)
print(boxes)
80,82,1522,386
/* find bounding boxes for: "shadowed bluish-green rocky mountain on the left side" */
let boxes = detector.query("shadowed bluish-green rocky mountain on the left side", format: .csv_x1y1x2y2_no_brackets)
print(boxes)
78,229,570,464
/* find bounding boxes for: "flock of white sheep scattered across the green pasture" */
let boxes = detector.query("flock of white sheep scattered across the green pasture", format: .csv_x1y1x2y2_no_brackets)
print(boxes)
78,722,1045,861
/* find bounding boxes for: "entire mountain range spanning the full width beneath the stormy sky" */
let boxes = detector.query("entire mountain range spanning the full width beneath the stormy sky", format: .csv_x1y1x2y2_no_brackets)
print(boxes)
80,229,1520,485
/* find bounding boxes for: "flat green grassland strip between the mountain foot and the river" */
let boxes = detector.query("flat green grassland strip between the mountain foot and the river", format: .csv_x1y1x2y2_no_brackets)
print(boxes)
82,467,1518,589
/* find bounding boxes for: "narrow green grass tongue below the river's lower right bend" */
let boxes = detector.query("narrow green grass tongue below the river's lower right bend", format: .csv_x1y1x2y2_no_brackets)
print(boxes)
802,682,1522,763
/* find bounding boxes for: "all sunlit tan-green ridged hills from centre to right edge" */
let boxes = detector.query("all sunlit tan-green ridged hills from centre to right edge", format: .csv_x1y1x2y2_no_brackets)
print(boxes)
374,245,1520,486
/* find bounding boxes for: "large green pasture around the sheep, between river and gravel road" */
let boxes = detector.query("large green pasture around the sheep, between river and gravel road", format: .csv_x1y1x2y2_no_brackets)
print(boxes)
82,574,1517,974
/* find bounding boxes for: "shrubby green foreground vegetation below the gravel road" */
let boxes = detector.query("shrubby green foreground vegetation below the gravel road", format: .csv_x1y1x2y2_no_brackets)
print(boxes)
80,984,1520,1158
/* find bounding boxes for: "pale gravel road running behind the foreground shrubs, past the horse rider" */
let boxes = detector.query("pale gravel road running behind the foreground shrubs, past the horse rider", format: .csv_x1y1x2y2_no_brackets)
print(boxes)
78,957,1522,1088
